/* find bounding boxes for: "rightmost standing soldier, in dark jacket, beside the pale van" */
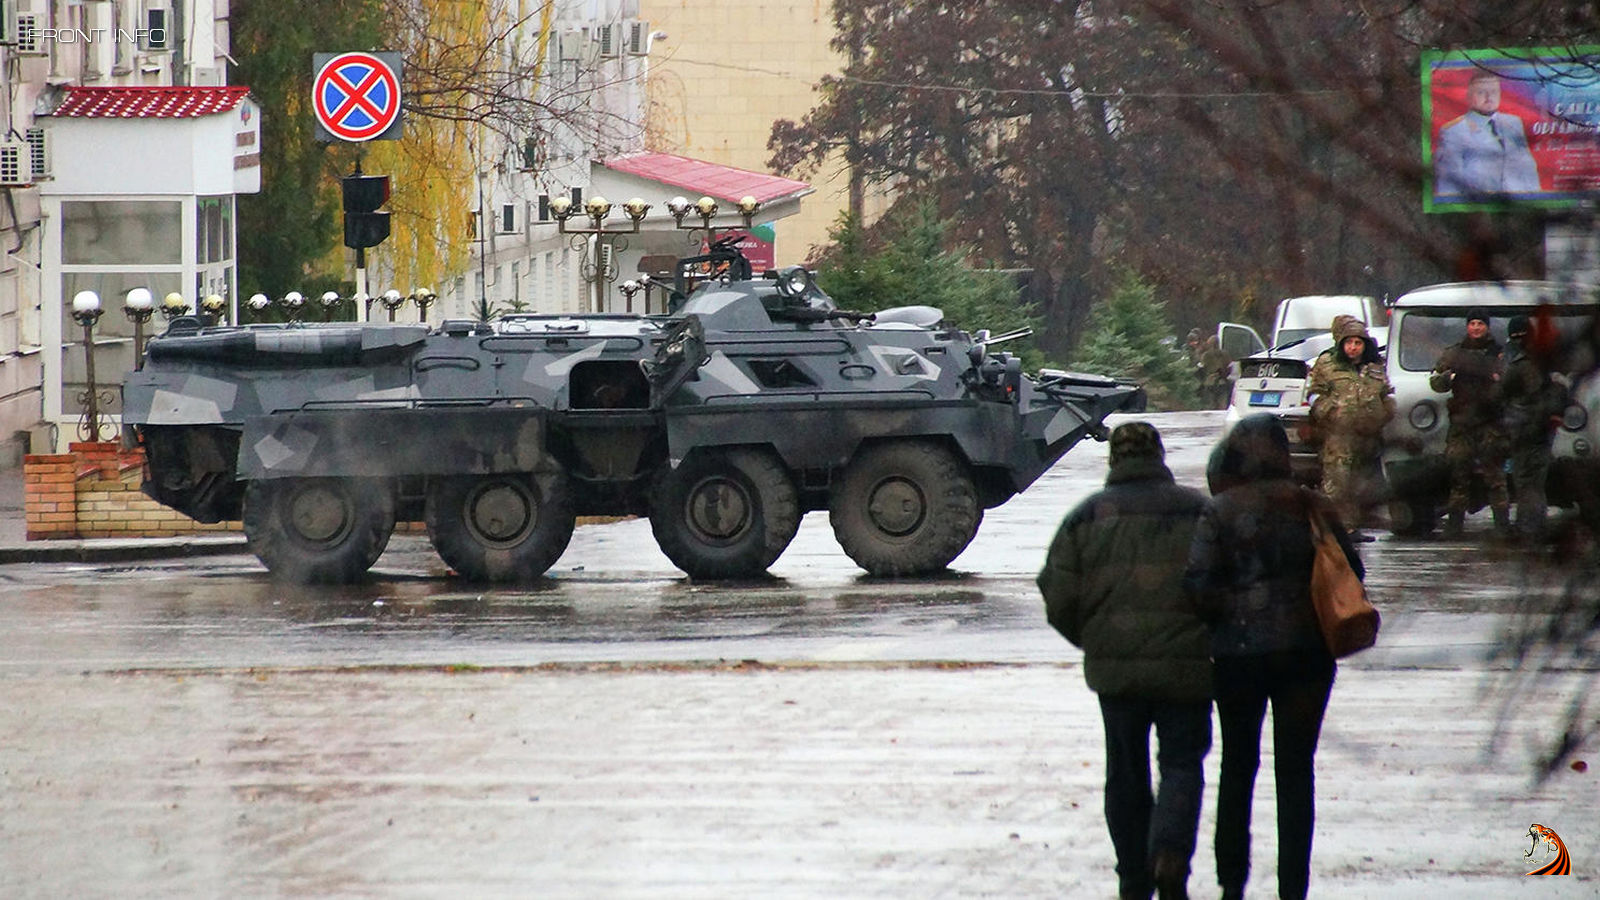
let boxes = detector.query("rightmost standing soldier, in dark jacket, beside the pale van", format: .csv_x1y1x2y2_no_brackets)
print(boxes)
1501,315,1566,540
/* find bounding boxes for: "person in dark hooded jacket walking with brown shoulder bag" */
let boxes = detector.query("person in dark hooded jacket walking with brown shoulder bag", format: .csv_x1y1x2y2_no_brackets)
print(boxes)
1184,413,1365,898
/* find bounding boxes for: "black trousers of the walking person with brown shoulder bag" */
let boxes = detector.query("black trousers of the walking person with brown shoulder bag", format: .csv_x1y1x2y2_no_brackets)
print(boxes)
1214,652,1334,900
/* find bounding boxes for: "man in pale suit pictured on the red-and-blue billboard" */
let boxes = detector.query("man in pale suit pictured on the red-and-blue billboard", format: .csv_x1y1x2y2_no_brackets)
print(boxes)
1434,69,1539,197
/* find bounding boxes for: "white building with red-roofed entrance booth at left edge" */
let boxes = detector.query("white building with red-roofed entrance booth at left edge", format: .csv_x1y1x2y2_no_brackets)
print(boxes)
0,0,246,451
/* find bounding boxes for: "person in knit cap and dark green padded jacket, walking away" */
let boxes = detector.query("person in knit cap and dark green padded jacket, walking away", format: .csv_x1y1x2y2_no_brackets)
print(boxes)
1038,421,1211,898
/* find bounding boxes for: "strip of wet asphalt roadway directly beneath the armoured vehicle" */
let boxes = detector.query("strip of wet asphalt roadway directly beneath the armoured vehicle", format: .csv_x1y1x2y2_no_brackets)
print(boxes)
0,413,1565,674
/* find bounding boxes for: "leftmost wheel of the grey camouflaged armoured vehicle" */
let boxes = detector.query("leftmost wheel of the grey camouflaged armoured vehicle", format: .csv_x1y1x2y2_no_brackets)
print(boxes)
243,477,395,585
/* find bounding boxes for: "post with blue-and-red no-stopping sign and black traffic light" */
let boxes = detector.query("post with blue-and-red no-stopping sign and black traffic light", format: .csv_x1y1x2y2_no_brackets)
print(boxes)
310,51,402,322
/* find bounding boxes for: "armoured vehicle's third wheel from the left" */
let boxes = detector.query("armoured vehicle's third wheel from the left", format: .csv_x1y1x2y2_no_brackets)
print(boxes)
650,448,800,580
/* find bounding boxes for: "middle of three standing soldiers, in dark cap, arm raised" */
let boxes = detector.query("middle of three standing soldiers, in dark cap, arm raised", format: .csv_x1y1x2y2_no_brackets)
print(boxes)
1427,309,1510,538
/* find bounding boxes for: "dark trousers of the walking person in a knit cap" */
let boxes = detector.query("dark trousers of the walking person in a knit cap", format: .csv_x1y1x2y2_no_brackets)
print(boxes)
1099,695,1211,897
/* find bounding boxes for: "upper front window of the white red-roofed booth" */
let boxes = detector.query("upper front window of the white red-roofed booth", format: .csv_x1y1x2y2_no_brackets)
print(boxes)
61,200,184,266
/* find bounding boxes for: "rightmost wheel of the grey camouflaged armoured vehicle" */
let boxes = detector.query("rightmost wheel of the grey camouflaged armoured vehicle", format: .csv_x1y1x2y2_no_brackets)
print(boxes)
827,442,982,575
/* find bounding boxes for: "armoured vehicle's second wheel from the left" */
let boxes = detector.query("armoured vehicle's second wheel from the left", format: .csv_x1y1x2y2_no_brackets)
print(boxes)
422,472,576,581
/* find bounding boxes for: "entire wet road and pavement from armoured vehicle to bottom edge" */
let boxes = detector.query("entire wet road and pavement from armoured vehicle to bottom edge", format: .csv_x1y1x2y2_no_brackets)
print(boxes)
0,413,1594,897
